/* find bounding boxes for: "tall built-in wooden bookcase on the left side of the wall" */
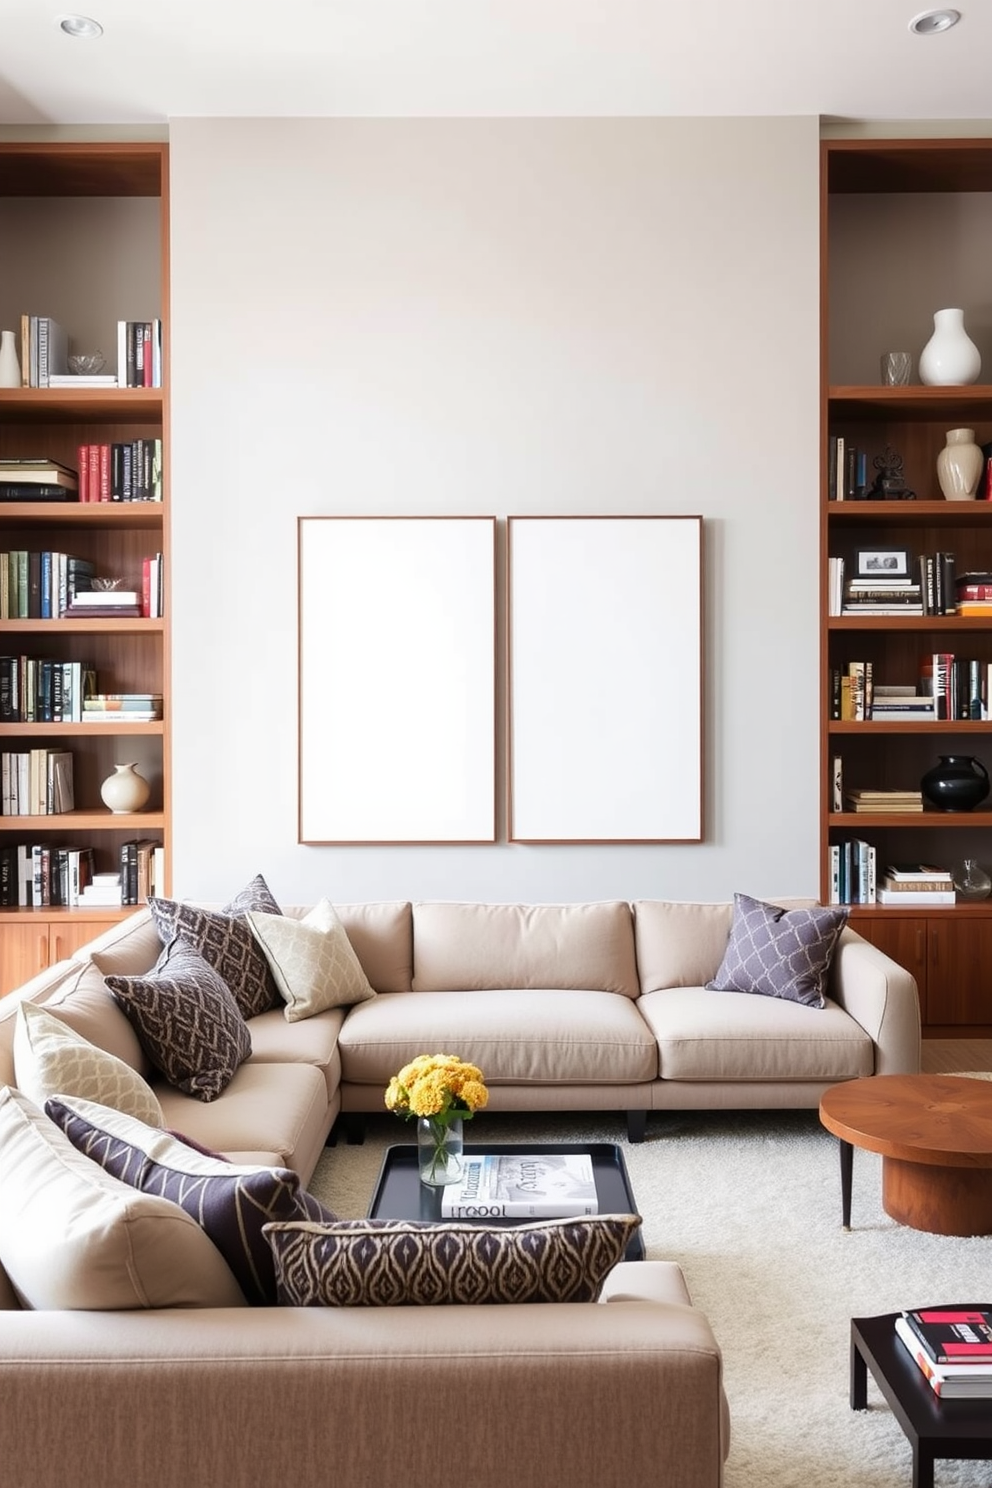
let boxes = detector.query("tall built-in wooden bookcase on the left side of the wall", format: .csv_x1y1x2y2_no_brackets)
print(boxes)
0,141,173,995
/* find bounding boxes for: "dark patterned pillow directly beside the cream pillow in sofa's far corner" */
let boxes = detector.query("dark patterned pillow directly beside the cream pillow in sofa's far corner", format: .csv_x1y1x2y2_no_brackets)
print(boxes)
149,873,283,1018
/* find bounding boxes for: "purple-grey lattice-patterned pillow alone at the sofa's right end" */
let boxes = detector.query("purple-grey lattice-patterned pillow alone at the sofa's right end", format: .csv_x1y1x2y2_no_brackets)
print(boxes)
706,894,848,1007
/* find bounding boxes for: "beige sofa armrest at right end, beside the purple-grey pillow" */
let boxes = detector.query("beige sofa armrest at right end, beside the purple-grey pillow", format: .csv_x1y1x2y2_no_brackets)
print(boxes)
830,926,921,1074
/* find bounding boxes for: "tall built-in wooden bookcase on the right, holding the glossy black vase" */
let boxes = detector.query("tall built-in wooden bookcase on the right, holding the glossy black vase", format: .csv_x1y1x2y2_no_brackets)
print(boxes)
819,138,992,1037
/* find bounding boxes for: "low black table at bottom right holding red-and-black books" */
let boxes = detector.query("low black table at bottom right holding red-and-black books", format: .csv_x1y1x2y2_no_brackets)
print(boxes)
851,1302,992,1488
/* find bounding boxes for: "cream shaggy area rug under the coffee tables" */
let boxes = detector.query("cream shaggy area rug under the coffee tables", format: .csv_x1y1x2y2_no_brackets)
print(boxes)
311,1112,992,1488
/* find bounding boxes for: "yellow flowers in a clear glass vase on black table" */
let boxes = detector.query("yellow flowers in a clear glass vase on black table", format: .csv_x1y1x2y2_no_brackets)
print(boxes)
385,1054,489,1187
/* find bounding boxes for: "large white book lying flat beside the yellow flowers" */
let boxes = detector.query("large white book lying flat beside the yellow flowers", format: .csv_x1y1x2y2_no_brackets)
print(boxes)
440,1152,599,1219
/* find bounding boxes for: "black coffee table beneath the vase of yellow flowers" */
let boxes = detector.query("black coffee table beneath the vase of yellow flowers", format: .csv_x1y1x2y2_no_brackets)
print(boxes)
367,1141,644,1260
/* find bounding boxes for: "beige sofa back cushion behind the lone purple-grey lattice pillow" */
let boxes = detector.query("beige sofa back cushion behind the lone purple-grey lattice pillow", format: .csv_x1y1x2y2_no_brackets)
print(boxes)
634,899,817,992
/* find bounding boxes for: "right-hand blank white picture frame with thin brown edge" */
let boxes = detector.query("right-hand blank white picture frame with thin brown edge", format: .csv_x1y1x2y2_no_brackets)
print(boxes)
507,516,702,842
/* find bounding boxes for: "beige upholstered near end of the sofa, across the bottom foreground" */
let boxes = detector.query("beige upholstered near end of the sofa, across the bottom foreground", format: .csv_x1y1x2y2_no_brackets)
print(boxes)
0,1301,727,1488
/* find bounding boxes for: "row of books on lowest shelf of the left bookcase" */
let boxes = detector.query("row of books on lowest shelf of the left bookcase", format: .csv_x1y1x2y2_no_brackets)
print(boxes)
0,838,165,909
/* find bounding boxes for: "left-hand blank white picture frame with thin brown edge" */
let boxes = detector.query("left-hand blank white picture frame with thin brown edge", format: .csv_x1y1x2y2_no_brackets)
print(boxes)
299,516,495,844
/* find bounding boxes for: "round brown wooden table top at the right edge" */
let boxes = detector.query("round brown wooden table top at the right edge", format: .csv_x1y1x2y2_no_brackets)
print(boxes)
819,1074,992,1168
